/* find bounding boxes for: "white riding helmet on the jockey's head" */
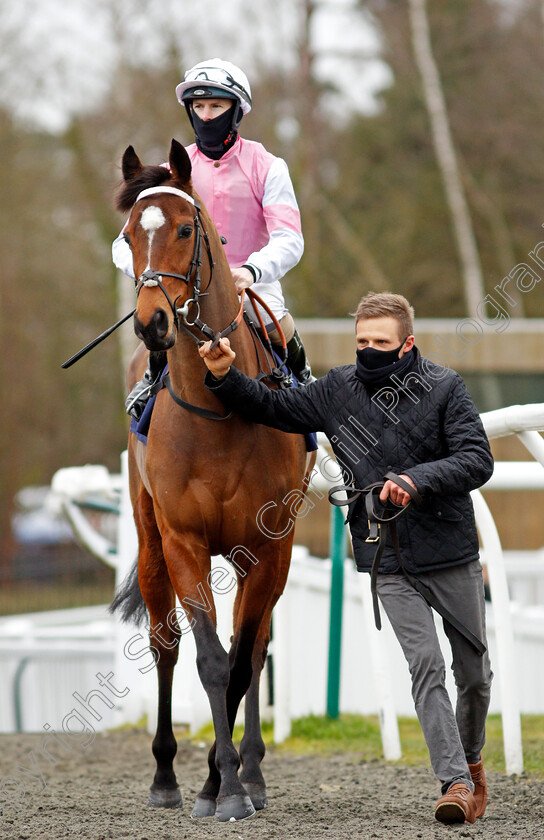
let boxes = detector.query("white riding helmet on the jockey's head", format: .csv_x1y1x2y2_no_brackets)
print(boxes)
176,58,251,114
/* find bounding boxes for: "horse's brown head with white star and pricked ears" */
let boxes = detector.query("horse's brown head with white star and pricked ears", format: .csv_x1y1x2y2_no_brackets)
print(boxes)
117,140,202,350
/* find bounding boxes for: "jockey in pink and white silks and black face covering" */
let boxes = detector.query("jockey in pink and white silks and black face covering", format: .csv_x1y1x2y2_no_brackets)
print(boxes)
112,58,314,417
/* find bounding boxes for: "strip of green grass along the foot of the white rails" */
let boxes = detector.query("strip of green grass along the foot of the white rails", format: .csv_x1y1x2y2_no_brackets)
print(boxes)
190,714,544,776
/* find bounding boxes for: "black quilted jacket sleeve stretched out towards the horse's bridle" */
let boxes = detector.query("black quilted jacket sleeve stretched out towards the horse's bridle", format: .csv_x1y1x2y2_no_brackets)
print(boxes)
204,367,328,434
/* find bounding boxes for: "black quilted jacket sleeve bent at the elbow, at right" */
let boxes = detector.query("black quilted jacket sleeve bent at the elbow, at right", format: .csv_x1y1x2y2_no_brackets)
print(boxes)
406,375,493,495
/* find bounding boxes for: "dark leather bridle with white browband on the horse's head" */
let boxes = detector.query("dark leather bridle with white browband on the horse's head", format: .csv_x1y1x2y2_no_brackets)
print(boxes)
134,186,244,345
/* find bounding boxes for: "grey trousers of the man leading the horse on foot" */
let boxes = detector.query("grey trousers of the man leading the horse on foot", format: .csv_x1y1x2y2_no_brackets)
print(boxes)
377,560,493,793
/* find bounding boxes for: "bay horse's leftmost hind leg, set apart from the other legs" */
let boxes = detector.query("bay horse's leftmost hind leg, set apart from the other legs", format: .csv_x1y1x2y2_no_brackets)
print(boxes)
135,491,182,808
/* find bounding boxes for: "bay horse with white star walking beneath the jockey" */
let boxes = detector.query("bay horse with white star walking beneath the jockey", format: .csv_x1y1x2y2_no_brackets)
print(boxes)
112,140,308,821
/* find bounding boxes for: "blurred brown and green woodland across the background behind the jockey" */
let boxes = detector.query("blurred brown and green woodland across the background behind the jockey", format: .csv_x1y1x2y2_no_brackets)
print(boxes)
0,0,544,572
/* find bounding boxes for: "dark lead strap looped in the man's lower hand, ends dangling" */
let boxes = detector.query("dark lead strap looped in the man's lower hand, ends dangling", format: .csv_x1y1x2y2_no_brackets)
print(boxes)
329,472,486,656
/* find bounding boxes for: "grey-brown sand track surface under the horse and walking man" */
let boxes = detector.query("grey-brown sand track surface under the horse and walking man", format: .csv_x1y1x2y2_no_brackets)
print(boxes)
0,730,544,840
